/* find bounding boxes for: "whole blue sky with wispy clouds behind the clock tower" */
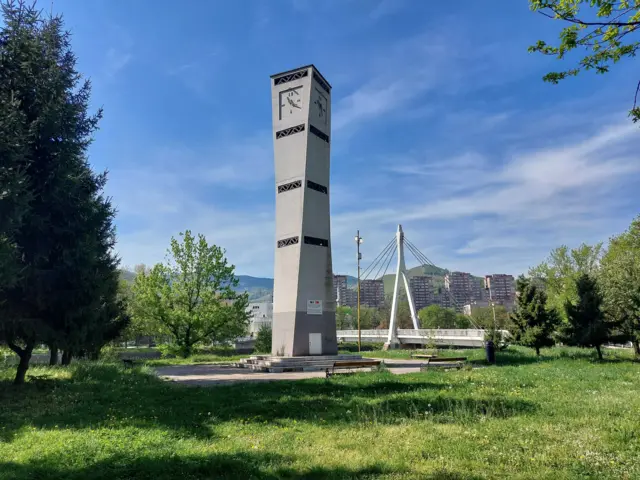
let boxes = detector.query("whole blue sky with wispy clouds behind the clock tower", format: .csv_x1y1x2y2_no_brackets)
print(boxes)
48,0,640,276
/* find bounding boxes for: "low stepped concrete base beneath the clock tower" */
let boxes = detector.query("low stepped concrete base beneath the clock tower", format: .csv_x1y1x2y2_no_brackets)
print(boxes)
236,355,362,373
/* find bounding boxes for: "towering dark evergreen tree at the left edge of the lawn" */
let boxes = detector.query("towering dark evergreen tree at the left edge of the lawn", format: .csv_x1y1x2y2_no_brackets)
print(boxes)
0,0,120,383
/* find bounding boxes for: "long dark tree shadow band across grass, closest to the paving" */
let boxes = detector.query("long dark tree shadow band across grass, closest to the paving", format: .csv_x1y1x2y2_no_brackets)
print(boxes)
0,364,535,441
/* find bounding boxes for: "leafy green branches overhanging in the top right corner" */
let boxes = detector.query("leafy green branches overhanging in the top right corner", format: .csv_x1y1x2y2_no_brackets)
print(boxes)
529,0,640,122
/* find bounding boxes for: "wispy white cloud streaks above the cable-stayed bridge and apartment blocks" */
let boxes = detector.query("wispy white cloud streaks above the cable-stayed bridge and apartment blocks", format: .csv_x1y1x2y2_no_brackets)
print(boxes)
332,117,640,273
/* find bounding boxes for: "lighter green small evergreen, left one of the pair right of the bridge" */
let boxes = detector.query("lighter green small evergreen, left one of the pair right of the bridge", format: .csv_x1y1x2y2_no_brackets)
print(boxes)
511,275,560,356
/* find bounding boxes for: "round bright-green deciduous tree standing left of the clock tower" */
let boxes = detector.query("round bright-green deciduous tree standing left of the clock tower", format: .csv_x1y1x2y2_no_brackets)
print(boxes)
133,230,249,357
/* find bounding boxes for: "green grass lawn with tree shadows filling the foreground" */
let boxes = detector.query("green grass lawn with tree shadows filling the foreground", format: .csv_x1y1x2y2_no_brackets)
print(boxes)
0,347,640,480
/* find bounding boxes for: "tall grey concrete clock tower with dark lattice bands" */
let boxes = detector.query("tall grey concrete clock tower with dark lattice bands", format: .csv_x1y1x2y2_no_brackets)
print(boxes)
271,65,338,356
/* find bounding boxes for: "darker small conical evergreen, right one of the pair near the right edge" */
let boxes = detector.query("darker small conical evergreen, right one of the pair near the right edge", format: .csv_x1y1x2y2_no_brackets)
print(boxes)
561,273,614,360
